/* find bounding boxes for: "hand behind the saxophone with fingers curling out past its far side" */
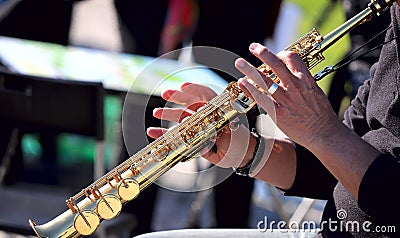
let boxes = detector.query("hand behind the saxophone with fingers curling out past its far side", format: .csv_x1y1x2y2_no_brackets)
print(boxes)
147,83,255,168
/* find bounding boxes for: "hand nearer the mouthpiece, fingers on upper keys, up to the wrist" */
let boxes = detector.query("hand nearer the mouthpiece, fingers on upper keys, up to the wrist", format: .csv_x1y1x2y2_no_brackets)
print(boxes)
235,43,341,147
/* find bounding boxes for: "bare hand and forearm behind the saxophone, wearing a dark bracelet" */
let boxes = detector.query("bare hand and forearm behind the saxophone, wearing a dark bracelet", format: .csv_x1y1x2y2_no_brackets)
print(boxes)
147,83,296,189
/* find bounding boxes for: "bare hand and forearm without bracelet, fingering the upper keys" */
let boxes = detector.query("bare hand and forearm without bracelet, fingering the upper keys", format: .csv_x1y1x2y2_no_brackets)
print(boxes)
235,43,380,199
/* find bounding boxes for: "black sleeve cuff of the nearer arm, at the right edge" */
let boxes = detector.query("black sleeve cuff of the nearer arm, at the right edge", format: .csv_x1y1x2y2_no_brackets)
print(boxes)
358,154,400,225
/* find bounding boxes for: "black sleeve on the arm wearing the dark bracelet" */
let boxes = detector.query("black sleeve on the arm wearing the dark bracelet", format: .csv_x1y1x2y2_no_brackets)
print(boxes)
282,144,337,200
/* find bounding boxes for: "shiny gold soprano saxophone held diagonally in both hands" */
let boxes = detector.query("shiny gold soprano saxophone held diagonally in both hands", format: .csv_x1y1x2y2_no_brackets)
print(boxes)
29,0,394,238
